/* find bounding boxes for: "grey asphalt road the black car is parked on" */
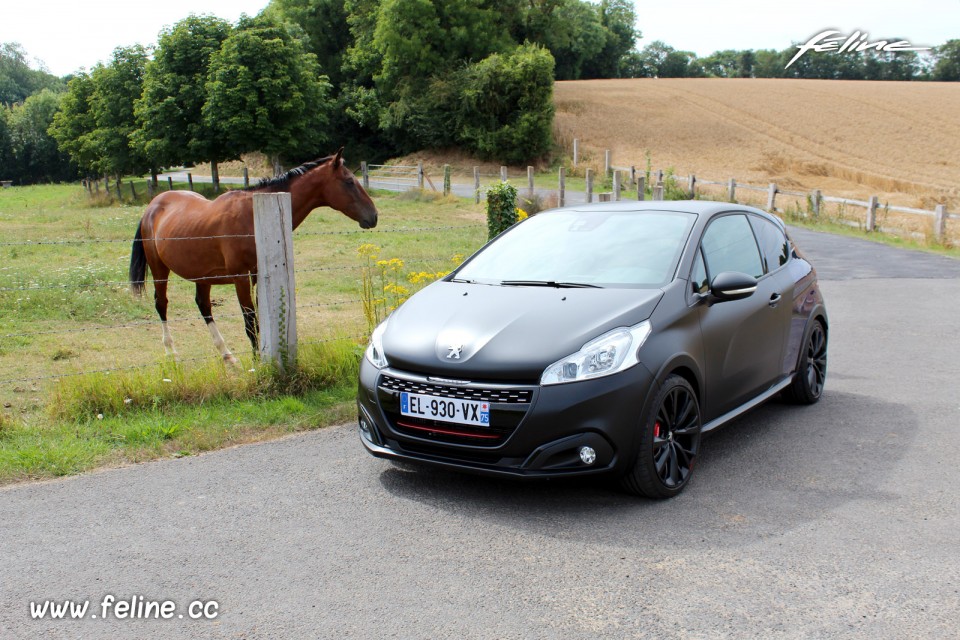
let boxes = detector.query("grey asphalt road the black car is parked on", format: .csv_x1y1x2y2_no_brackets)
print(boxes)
0,230,960,640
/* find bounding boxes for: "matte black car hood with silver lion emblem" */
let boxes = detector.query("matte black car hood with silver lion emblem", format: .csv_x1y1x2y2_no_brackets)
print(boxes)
383,282,663,382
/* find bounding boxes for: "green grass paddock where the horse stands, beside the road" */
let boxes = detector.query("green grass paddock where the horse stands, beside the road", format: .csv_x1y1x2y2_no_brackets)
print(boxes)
0,186,486,483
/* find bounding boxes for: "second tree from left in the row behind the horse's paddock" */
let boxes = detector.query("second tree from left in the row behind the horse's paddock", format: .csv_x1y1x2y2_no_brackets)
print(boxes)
90,44,151,177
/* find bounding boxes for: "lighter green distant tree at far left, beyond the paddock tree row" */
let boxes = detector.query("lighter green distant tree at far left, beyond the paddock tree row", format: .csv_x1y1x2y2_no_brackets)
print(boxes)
9,89,77,184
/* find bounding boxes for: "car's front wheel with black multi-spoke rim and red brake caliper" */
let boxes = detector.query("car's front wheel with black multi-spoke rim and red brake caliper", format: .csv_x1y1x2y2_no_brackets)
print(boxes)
621,375,703,500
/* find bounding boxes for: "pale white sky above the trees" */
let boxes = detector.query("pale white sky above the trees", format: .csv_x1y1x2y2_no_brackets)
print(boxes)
0,0,960,76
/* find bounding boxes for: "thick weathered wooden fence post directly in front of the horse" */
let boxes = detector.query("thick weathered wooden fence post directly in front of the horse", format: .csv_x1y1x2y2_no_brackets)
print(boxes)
253,193,297,371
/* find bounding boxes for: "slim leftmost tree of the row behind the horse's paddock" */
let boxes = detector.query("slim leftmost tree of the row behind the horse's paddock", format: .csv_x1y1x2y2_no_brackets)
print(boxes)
48,73,100,176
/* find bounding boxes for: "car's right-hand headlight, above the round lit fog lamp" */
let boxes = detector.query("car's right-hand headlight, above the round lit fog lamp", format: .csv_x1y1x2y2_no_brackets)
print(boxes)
540,321,650,385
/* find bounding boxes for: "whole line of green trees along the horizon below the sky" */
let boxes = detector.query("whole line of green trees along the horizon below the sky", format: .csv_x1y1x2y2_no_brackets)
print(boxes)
0,0,960,184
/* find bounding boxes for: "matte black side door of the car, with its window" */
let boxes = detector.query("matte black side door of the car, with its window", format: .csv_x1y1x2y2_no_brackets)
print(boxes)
695,213,792,419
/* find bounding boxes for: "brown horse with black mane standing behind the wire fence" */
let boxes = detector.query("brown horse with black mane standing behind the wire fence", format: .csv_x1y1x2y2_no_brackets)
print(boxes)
130,147,377,364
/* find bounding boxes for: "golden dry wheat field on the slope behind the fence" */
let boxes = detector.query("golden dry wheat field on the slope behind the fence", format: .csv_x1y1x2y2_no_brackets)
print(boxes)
555,78,960,212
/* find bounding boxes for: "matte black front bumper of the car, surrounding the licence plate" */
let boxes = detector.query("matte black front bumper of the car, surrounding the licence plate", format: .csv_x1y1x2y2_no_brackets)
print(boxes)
357,360,654,478
